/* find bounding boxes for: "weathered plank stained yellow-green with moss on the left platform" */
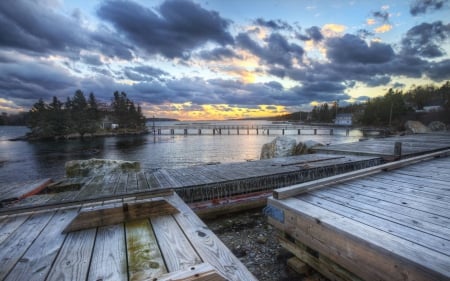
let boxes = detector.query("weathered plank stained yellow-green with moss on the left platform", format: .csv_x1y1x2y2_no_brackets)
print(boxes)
125,220,167,280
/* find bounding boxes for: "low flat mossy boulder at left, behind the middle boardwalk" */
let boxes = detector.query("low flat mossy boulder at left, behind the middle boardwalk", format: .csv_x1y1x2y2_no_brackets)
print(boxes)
65,158,141,178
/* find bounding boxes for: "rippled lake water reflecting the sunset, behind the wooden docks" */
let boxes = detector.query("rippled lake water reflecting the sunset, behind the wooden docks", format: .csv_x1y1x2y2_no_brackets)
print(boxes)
0,121,361,184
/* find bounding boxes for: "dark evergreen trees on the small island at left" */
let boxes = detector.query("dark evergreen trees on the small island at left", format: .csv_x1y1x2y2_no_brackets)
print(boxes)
28,90,145,138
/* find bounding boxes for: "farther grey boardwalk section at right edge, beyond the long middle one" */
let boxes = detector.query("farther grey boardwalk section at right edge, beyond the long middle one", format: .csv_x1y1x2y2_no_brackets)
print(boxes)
314,132,450,158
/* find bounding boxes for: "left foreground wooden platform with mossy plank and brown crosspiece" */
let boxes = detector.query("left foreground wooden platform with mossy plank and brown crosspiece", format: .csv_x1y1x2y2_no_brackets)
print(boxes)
0,189,256,281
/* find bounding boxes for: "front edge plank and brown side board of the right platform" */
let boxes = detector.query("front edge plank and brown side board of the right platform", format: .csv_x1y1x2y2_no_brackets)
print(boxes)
268,198,450,280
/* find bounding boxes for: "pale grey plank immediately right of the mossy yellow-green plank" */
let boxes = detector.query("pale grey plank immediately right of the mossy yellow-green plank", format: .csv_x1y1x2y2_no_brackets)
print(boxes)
151,213,202,270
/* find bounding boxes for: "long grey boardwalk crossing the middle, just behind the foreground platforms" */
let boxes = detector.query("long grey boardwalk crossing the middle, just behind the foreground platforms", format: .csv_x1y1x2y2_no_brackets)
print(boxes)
0,154,381,212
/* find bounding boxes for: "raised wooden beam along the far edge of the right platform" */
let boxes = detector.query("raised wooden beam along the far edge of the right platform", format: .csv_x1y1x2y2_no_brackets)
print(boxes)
273,149,450,199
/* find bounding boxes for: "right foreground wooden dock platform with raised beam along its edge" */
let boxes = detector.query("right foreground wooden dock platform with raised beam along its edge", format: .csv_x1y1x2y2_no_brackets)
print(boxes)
267,150,450,280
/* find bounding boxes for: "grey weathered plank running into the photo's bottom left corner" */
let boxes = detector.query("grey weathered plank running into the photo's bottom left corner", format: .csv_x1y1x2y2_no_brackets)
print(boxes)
0,212,54,280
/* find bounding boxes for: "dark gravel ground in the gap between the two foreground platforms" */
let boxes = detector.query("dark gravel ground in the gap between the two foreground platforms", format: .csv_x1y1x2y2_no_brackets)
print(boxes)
205,207,326,281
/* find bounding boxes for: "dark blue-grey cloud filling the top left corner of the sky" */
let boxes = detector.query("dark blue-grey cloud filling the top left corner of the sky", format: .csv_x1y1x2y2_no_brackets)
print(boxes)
0,0,89,52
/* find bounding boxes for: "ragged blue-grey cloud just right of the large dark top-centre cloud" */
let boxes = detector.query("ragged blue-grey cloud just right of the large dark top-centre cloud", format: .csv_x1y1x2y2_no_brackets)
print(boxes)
236,33,304,68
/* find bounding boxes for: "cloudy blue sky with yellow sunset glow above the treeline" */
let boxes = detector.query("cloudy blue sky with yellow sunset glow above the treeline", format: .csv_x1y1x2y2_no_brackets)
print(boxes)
0,0,450,120
